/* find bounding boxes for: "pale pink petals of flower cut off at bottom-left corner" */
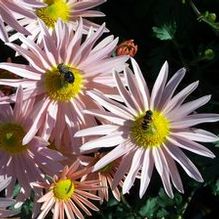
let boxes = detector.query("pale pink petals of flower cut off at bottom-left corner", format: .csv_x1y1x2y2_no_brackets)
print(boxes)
0,176,17,218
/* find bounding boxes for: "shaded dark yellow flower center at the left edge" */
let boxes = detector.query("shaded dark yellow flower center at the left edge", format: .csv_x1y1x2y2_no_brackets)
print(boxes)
0,123,27,154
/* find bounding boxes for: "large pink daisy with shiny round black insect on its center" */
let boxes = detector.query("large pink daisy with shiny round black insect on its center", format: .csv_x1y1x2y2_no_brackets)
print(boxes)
0,21,128,154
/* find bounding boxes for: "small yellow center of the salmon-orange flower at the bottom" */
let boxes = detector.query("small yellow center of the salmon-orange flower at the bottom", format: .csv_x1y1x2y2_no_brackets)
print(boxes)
53,179,75,200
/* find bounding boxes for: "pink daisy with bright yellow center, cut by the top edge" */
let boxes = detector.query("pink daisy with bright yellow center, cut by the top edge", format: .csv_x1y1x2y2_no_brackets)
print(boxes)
8,0,108,41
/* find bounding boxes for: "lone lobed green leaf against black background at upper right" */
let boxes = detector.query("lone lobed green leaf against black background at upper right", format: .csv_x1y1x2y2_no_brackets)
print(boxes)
152,22,176,40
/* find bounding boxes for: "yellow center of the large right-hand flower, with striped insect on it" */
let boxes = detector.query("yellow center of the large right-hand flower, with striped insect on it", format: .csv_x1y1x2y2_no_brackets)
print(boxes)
130,110,170,148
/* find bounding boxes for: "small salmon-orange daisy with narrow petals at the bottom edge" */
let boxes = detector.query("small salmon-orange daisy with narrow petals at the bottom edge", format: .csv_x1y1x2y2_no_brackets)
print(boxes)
34,160,101,219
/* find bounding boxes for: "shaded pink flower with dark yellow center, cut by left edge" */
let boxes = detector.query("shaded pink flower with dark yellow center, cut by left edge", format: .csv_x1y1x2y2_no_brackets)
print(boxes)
0,88,64,201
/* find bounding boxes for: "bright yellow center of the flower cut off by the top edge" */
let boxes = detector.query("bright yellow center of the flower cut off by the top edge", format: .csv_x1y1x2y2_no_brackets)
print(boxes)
36,0,70,28
